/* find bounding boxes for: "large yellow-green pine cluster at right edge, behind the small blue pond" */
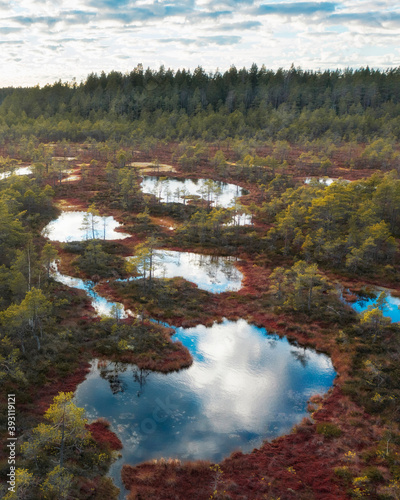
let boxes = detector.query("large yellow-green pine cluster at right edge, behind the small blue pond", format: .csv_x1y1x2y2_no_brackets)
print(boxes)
263,172,400,272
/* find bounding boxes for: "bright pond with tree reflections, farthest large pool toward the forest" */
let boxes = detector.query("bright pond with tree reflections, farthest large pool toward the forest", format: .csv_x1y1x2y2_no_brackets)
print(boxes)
141,175,248,208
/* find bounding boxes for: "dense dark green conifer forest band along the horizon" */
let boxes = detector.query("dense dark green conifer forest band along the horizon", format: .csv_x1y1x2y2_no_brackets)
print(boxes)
0,64,400,141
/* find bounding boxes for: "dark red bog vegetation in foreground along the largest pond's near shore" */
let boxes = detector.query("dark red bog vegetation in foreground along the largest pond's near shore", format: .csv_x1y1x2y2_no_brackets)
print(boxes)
122,388,388,500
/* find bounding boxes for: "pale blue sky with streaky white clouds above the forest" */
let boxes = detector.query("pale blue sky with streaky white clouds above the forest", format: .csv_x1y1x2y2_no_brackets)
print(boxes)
0,0,400,87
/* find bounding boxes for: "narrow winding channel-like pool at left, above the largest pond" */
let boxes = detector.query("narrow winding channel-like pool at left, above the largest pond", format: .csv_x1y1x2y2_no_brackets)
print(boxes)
51,263,132,318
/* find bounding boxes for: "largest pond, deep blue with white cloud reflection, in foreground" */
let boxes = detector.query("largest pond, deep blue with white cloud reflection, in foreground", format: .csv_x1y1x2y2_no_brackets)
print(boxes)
75,319,335,491
